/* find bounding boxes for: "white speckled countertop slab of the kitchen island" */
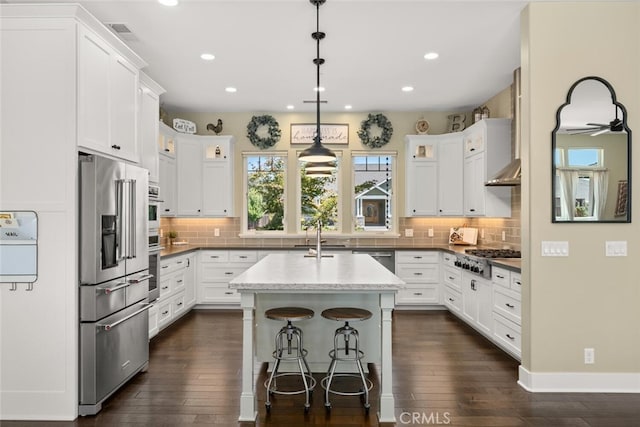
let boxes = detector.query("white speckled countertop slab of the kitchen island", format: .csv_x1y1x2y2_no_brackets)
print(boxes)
229,253,405,291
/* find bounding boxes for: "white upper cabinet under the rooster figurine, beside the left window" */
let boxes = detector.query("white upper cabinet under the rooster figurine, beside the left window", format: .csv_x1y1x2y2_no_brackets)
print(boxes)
176,135,233,217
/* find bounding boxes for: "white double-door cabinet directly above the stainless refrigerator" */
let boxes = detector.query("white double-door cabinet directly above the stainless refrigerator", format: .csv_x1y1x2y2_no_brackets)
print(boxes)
78,26,140,163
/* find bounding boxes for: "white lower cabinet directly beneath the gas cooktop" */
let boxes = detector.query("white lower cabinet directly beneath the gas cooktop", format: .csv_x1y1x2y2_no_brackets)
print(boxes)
462,271,493,337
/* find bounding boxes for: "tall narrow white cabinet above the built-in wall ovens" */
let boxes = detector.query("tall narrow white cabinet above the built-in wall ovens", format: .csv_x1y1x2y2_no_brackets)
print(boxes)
138,72,164,184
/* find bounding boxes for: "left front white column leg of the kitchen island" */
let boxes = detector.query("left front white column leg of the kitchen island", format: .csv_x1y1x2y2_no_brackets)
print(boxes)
238,292,258,421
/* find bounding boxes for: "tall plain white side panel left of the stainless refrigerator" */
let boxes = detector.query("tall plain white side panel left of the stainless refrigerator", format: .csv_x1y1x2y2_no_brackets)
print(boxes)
0,18,78,420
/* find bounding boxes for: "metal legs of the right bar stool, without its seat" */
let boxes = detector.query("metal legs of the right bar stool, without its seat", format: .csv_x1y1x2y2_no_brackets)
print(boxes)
321,322,373,413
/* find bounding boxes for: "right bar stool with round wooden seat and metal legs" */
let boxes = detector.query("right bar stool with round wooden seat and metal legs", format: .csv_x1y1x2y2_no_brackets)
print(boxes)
320,307,373,414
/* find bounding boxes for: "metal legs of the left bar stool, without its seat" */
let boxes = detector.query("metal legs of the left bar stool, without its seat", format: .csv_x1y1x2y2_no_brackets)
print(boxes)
265,320,316,413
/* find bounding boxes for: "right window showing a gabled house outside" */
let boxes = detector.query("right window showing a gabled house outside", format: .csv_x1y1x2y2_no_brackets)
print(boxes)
352,152,396,233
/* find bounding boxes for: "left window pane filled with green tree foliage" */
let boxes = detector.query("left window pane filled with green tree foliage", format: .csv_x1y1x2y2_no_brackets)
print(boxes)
246,156,286,230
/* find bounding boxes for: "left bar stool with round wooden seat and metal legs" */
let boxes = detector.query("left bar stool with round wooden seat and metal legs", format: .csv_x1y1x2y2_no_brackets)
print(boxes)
264,307,316,413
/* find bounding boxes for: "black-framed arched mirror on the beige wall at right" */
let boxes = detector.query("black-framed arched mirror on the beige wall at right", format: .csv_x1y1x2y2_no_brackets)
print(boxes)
552,77,631,222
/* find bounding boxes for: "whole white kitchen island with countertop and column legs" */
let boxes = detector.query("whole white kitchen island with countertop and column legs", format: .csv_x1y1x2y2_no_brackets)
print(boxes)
229,253,404,422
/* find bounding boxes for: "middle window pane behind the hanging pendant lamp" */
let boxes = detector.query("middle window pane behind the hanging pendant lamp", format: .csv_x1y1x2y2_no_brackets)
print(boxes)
300,160,340,231
